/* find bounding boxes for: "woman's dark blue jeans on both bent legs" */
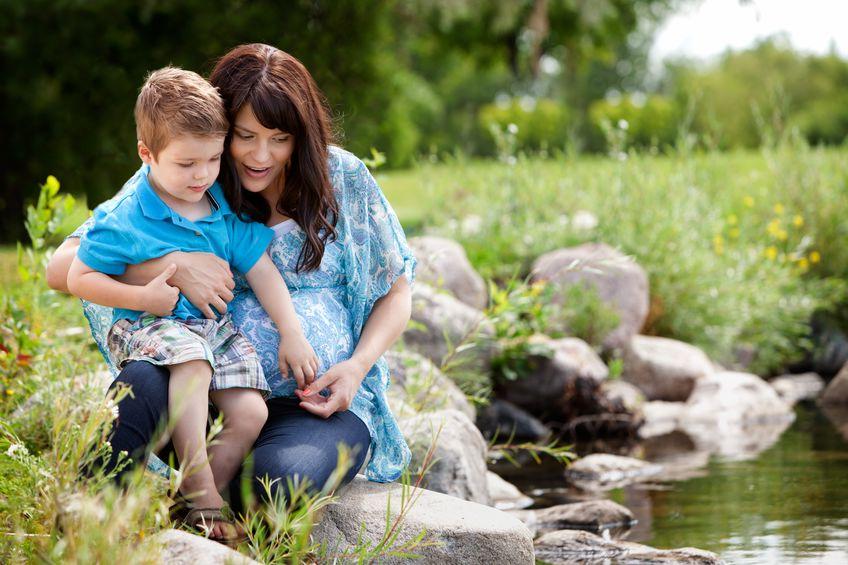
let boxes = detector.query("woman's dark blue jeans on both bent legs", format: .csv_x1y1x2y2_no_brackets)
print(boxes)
107,361,371,510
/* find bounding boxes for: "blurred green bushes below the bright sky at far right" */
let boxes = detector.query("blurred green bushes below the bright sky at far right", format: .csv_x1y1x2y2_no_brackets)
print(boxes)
667,37,848,148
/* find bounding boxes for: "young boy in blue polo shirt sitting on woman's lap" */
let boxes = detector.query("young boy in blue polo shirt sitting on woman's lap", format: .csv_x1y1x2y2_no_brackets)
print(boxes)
68,67,318,540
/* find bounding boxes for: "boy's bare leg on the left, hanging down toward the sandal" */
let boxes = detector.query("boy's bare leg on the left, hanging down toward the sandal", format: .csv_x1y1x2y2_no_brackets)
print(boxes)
168,361,224,508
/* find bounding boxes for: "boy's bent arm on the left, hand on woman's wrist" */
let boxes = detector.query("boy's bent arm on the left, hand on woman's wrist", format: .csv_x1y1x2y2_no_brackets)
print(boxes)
67,256,180,316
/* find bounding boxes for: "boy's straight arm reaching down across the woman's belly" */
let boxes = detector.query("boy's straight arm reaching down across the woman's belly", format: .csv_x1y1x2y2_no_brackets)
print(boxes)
245,253,318,389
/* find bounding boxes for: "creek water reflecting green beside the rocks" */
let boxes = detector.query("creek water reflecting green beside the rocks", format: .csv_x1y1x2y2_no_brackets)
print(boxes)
497,405,848,564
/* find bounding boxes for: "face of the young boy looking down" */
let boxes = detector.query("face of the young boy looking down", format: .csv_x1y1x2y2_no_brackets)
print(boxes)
138,135,224,204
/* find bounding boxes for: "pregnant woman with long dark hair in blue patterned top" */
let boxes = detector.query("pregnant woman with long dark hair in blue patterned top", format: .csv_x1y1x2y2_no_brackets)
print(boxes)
47,44,415,500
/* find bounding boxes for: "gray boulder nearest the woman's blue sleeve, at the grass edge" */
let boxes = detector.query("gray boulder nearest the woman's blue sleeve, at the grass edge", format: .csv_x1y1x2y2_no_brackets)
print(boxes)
409,236,489,310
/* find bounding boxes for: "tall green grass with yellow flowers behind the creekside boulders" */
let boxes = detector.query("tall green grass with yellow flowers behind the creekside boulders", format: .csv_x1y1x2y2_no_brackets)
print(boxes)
410,139,848,372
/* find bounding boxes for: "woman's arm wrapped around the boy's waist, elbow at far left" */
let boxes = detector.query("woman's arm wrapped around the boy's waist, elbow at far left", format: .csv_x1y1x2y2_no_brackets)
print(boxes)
46,237,235,319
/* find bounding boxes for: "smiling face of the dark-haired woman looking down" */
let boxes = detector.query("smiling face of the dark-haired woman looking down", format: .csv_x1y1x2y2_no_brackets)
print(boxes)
230,105,294,192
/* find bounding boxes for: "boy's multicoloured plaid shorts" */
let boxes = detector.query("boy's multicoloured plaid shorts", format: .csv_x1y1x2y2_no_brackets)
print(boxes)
106,314,271,398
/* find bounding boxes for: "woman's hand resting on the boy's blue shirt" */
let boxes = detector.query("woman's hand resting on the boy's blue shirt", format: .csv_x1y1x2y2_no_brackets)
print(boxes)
165,252,235,320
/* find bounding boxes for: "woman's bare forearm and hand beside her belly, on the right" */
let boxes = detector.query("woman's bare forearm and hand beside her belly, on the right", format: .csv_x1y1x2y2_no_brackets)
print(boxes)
295,276,412,418
